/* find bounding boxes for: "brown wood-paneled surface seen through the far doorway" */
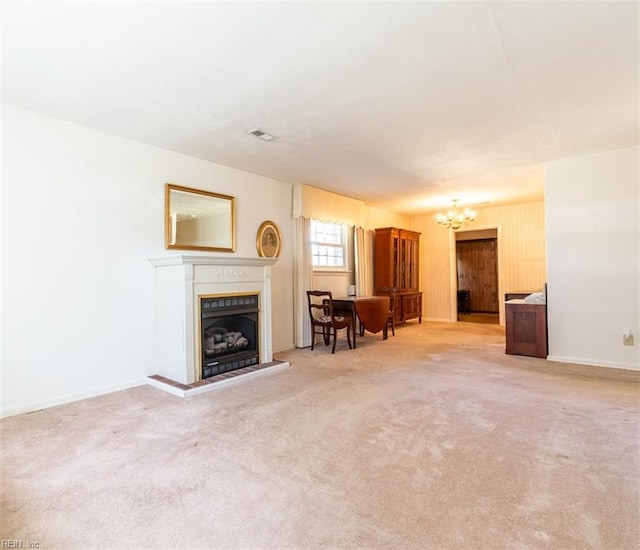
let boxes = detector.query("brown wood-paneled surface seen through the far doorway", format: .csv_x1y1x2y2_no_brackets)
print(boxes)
456,239,499,313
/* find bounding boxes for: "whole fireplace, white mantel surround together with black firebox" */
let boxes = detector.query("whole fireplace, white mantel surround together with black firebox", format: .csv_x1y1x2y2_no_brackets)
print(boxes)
150,254,277,384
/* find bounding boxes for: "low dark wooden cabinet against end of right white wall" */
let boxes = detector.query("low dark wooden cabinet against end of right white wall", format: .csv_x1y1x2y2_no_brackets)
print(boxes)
505,299,548,358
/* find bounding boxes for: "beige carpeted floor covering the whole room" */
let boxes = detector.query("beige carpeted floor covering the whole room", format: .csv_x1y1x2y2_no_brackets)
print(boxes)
0,323,640,550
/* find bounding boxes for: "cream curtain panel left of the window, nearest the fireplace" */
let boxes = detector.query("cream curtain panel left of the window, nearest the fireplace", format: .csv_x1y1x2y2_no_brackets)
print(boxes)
293,216,313,348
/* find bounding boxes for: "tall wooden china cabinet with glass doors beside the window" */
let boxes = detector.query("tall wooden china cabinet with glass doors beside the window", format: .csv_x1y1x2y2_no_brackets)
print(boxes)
374,227,422,323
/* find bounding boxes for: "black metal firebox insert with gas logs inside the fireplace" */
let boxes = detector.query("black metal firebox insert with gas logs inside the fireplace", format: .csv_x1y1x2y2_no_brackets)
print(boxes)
200,294,259,379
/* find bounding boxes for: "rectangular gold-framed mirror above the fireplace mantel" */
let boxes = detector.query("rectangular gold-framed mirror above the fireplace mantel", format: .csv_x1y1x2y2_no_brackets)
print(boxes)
164,183,236,252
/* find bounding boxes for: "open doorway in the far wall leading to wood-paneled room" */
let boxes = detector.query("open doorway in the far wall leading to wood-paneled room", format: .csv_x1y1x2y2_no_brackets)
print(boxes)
456,229,500,324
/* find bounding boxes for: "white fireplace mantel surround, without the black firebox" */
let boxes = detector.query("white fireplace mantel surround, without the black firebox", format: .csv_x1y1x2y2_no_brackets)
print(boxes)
149,254,277,384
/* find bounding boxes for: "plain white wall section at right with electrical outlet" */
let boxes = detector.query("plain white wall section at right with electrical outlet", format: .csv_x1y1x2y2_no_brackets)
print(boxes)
545,148,640,370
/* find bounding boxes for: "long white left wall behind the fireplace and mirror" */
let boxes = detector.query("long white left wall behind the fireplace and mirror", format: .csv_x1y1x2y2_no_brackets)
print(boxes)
2,106,293,414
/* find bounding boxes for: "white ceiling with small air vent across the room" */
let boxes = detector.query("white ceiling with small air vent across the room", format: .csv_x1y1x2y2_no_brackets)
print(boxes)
2,2,639,213
